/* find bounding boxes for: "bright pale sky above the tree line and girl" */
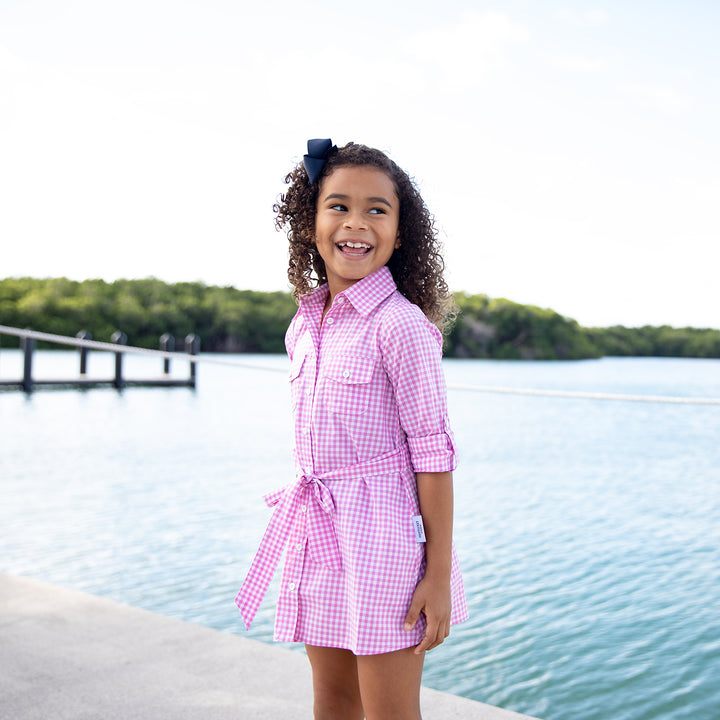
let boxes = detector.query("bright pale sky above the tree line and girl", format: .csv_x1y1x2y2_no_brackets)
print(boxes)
0,0,720,328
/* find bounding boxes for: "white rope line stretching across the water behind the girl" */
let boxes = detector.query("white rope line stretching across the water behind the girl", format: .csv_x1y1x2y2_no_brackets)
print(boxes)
0,325,720,405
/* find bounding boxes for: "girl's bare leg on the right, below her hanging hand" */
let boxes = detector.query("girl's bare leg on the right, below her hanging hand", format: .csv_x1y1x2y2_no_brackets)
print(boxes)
357,647,425,720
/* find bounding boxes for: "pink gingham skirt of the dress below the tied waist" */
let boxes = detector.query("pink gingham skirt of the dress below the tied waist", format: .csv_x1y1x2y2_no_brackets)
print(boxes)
275,464,468,655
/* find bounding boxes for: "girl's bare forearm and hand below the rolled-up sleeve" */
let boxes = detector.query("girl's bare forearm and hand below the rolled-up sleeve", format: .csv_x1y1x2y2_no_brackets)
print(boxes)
405,472,453,655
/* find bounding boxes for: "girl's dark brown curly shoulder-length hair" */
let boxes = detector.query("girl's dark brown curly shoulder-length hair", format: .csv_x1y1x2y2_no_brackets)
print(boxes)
273,143,457,333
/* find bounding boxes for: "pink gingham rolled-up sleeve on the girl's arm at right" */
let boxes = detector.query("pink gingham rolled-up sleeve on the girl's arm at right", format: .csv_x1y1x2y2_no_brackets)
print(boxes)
381,306,457,472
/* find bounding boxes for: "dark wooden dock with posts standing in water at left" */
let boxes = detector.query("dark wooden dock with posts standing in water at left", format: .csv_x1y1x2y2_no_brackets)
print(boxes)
0,325,200,393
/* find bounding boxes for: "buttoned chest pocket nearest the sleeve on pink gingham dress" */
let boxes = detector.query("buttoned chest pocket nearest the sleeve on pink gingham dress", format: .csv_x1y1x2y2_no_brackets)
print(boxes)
323,355,376,415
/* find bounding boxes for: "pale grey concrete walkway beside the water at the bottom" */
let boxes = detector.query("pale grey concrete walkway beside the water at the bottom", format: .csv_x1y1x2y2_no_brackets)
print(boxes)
0,573,527,720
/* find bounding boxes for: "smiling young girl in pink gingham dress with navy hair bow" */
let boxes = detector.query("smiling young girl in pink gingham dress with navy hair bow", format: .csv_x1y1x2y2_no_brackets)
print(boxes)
236,140,467,720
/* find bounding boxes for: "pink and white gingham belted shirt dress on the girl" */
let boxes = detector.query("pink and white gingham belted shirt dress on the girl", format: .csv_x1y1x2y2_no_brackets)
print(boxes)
235,267,468,655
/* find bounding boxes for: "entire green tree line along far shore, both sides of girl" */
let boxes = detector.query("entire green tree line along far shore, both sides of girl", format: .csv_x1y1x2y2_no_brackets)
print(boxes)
0,277,720,360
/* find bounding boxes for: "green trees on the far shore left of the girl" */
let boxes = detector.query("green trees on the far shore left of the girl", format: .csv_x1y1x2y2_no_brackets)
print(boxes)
0,278,297,353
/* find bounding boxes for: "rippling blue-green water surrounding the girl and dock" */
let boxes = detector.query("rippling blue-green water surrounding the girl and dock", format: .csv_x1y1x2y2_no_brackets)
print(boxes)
0,350,720,720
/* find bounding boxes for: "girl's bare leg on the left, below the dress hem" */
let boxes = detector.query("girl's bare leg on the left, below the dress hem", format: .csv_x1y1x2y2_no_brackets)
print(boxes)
305,645,365,720
